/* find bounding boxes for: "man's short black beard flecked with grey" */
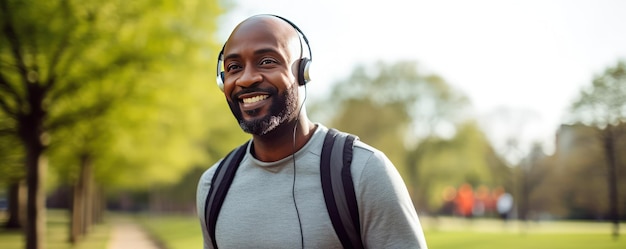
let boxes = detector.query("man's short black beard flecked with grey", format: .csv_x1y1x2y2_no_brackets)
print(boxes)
227,87,298,136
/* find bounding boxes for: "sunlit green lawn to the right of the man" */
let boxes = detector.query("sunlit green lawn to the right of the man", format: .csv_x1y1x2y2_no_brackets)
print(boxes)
422,218,626,249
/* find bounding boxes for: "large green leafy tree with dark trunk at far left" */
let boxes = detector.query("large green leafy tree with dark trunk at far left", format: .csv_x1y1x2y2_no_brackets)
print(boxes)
0,0,224,248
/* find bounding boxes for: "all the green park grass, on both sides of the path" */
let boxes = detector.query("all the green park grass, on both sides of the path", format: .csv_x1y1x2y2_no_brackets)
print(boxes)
0,211,626,249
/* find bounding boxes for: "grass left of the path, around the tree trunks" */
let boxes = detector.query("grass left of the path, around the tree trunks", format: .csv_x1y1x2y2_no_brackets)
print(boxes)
0,210,110,249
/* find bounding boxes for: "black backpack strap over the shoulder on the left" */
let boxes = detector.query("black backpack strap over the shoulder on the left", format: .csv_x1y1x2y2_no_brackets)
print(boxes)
204,142,248,248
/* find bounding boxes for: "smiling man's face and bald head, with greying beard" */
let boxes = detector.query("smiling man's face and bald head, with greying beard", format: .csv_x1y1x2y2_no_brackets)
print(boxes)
224,17,299,135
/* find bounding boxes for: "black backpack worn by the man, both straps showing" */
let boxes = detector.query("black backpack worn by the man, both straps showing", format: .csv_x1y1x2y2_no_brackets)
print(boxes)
204,129,363,248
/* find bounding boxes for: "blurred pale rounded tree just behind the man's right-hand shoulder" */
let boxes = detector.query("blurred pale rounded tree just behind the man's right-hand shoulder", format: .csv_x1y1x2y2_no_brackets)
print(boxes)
311,61,498,210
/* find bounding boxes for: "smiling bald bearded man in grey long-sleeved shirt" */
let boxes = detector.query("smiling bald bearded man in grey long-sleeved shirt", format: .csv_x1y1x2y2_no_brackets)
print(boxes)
197,15,426,248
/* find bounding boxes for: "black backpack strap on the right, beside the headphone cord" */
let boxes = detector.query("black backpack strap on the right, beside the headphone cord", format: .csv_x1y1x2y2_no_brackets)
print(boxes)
320,129,363,248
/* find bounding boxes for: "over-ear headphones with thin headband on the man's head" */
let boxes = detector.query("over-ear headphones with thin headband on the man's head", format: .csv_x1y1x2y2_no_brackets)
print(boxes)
216,15,313,92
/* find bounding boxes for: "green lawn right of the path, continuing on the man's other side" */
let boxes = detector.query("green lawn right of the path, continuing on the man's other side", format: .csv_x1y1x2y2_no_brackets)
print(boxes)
140,216,626,249
